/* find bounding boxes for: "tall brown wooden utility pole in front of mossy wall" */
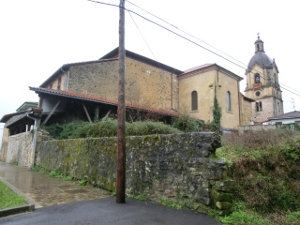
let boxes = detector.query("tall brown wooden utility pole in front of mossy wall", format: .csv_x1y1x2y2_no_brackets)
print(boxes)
116,0,126,203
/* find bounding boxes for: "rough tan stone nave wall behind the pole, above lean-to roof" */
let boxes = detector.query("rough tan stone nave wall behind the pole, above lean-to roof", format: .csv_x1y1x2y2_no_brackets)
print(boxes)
68,58,178,111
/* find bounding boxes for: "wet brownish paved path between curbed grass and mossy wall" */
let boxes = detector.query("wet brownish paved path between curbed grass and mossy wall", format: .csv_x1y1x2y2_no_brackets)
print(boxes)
0,161,110,207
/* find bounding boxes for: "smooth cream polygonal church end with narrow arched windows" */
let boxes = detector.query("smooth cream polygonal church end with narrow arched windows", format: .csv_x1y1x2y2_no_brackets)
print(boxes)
179,64,242,129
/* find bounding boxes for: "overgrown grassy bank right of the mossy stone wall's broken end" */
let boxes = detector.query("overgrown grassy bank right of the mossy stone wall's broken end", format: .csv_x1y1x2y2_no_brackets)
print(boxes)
210,129,300,225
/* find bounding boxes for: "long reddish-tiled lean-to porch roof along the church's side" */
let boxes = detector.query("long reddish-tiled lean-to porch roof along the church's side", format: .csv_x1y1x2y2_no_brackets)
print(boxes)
29,87,179,116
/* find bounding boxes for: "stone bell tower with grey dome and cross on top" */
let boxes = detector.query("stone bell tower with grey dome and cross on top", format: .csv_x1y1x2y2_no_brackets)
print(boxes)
245,34,283,122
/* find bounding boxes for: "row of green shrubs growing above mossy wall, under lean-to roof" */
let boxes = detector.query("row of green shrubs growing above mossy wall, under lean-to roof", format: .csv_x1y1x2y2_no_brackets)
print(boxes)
42,115,214,139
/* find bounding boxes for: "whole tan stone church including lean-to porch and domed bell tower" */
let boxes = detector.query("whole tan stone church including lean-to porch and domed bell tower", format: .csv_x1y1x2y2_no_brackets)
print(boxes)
1,36,283,135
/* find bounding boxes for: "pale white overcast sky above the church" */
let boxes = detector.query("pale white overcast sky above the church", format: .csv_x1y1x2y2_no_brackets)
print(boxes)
0,0,300,137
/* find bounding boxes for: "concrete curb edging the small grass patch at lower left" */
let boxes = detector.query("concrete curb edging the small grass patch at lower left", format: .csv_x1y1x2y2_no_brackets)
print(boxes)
0,177,42,217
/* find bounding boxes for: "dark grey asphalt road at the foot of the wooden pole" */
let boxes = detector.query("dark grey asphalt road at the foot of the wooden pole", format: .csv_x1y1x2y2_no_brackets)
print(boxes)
0,197,220,225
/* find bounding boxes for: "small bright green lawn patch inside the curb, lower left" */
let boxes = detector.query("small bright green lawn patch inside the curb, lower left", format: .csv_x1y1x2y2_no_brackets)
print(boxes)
0,182,27,209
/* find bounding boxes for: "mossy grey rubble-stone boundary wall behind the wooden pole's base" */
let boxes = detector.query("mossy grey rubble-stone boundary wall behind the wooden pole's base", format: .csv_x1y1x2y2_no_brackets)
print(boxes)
37,133,233,213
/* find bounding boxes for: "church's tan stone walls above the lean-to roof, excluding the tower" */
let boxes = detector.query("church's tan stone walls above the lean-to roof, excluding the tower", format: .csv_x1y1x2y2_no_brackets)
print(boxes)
35,48,252,129
